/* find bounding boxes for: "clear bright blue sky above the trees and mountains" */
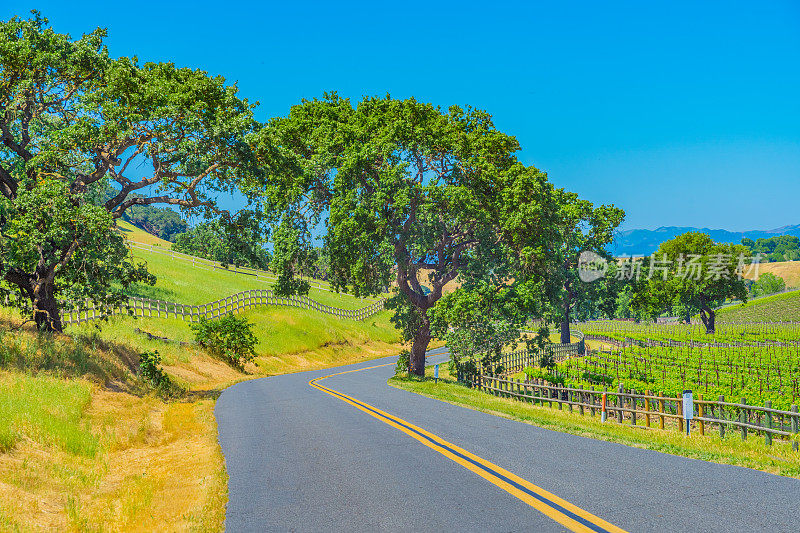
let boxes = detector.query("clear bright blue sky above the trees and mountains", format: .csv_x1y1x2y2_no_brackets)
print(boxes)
0,0,800,230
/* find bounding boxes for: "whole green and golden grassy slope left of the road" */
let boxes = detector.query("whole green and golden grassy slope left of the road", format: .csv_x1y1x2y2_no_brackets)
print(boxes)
0,219,400,531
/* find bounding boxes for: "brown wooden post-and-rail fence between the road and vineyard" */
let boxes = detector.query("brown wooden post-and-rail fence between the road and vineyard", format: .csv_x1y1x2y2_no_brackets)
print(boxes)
459,374,800,450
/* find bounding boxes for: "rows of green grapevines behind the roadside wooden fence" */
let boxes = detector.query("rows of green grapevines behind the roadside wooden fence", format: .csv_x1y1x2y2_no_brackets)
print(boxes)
532,321,800,409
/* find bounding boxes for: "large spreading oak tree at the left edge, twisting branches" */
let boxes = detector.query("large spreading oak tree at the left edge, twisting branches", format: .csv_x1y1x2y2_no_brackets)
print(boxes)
0,13,255,331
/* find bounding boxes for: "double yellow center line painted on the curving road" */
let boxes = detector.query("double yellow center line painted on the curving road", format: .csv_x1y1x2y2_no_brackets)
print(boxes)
308,363,624,533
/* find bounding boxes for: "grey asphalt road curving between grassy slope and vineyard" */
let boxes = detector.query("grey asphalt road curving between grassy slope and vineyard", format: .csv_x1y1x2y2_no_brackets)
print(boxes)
215,348,800,532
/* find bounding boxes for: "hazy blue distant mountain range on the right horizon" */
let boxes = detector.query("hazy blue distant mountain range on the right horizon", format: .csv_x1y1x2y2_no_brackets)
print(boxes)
610,224,800,256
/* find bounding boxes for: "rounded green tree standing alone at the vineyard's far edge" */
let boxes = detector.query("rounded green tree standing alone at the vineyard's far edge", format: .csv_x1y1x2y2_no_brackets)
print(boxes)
632,232,749,333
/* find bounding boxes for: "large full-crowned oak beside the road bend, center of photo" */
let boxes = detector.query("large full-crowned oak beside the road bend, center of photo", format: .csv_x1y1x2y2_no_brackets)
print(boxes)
261,94,580,375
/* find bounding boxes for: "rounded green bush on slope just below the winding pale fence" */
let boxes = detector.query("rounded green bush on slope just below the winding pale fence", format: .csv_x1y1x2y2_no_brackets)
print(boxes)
191,315,258,370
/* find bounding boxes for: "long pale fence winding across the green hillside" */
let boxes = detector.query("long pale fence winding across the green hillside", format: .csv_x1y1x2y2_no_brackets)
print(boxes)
61,289,384,325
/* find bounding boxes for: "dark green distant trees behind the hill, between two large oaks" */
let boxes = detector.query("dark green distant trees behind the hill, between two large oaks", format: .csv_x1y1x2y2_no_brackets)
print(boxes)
172,211,270,269
